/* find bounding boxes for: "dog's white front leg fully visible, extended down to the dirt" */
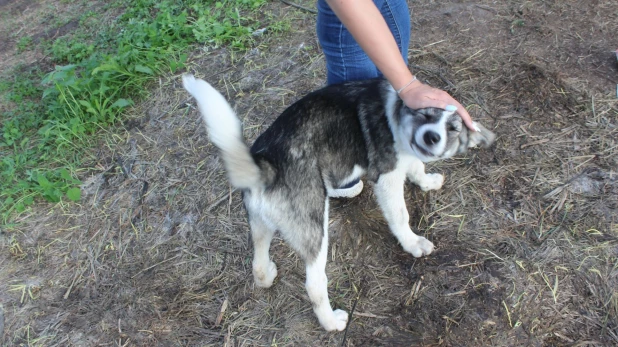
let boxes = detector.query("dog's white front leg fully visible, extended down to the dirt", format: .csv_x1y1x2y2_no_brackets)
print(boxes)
374,170,433,257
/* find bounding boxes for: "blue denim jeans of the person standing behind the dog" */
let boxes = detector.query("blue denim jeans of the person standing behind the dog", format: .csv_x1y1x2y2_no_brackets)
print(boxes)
317,0,410,84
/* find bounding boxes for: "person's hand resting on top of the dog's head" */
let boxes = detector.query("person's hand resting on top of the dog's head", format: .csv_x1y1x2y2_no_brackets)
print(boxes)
399,80,478,131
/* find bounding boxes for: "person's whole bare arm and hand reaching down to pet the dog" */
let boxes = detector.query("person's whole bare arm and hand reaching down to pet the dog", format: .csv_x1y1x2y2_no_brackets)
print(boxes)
326,0,475,130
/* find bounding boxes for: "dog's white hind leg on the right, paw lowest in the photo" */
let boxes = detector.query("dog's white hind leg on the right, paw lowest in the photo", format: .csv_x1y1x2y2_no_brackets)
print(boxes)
305,198,348,331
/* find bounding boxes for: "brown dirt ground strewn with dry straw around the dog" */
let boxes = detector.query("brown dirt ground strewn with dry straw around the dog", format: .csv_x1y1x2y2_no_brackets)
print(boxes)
0,0,618,346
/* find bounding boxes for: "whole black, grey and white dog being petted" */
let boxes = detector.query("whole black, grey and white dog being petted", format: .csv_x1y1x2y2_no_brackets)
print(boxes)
183,75,495,331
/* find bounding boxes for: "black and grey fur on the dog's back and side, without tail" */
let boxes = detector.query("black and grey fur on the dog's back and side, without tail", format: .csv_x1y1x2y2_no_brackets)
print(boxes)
251,79,396,188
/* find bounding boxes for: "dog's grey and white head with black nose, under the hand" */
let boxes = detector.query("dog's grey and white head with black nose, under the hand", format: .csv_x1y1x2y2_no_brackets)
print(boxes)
400,107,496,162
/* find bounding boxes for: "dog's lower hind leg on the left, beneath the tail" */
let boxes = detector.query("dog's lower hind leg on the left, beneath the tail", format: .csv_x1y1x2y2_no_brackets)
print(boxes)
249,215,277,288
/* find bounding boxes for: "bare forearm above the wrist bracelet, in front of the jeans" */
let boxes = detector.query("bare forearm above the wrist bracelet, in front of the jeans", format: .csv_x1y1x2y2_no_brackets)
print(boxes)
326,0,412,89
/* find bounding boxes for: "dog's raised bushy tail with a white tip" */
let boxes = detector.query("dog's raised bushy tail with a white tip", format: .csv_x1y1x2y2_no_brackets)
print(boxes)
182,75,262,189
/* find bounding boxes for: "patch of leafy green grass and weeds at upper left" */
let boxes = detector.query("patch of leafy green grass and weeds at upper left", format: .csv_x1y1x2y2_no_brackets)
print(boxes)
0,0,265,224
